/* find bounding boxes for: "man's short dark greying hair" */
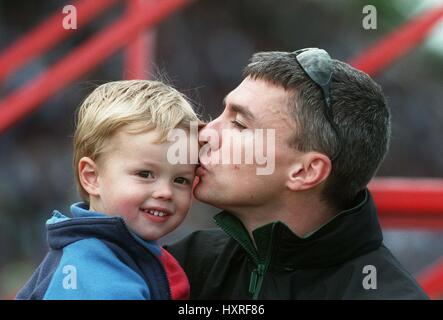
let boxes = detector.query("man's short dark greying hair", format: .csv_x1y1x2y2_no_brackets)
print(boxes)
244,52,391,209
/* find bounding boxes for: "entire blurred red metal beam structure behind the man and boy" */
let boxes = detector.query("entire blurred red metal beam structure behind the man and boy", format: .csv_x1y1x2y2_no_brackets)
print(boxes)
0,0,443,298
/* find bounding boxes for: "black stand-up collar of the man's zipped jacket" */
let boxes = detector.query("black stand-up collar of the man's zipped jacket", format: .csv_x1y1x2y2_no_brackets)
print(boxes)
214,189,383,270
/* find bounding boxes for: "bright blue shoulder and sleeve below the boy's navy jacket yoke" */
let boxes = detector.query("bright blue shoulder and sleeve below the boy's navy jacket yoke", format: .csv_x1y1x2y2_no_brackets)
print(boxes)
17,238,150,300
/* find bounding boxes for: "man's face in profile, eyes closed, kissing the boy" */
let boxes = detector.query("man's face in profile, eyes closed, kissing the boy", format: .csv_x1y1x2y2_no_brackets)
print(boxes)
194,77,296,211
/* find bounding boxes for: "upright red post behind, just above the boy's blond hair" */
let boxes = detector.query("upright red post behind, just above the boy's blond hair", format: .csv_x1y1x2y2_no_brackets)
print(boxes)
123,0,156,80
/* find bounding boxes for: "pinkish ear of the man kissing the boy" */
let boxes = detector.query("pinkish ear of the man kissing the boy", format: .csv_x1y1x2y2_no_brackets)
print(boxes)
286,152,332,191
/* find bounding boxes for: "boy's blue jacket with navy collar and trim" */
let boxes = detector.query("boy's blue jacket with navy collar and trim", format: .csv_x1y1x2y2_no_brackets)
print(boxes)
17,203,182,300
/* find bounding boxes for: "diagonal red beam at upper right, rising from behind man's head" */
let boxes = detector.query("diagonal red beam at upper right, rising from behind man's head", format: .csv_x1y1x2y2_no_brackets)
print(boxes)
350,6,443,75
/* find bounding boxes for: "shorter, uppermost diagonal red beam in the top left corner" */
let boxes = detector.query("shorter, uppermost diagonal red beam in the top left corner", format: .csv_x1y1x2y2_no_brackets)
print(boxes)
0,0,116,82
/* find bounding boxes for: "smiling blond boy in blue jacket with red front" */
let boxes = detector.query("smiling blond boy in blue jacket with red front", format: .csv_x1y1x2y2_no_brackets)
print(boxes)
17,80,198,299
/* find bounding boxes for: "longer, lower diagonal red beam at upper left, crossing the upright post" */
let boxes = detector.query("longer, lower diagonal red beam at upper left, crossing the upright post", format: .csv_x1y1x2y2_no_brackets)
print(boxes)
0,0,191,133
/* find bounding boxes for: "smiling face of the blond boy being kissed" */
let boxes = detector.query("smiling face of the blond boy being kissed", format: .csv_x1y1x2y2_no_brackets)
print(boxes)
91,130,196,240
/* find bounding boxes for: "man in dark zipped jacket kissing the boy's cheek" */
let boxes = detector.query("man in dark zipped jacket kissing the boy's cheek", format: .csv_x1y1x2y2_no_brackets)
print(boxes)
167,48,427,299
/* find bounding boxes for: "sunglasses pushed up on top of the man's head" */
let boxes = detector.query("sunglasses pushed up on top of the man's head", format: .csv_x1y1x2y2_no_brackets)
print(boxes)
293,48,342,162
